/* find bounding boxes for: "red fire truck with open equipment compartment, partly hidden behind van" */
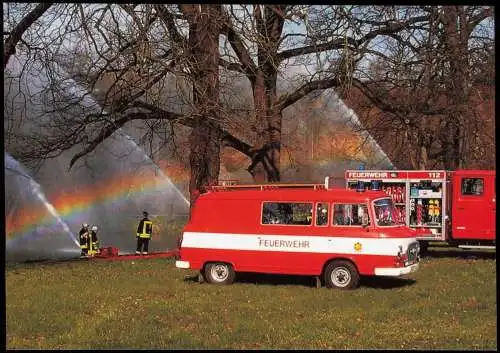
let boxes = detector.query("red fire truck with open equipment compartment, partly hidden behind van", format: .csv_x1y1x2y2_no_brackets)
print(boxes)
345,170,496,252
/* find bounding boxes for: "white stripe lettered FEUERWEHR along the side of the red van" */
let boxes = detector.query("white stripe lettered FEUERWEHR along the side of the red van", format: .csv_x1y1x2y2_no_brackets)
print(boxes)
181,232,416,255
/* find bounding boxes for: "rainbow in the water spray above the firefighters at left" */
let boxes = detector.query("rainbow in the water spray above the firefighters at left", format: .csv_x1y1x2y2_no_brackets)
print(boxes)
6,168,187,238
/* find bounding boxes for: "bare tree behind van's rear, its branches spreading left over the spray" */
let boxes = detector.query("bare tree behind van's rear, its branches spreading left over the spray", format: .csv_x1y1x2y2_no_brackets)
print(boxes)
3,4,241,204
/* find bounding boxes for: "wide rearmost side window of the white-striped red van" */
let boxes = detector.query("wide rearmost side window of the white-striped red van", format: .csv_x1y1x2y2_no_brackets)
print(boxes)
262,202,313,225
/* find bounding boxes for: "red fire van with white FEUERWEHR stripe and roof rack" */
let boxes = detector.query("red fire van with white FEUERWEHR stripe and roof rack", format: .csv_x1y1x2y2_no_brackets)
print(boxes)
176,178,420,289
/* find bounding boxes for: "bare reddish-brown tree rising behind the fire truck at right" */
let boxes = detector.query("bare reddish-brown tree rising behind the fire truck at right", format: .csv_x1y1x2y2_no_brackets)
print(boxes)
344,6,494,169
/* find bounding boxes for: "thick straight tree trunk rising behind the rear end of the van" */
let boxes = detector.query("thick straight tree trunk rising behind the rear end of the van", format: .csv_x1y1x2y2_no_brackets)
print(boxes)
182,4,221,207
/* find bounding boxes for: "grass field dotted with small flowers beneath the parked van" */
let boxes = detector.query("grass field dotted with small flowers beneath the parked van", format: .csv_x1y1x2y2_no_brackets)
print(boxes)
5,248,497,350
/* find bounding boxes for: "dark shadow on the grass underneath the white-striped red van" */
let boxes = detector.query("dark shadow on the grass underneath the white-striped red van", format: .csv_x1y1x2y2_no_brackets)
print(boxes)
184,272,416,289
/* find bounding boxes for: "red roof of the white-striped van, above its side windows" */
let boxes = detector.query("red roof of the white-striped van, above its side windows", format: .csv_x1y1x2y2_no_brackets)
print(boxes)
200,187,388,202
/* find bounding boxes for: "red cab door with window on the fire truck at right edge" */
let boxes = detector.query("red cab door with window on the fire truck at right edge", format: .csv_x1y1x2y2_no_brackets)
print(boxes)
452,170,496,241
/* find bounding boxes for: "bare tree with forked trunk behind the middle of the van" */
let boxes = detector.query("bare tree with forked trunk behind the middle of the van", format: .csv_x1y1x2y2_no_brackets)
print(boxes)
221,5,428,181
